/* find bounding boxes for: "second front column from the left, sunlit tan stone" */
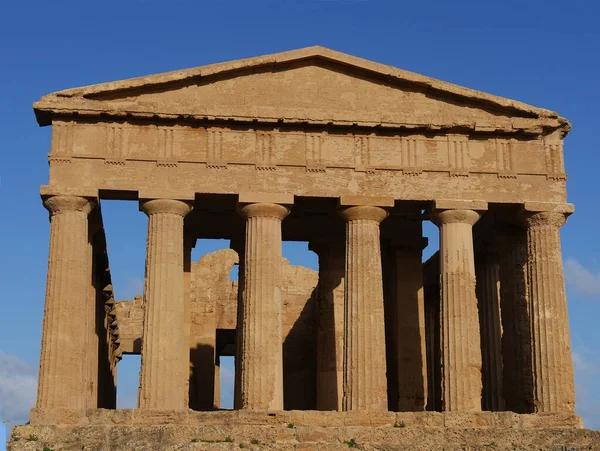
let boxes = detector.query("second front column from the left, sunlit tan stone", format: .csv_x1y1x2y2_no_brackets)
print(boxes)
139,199,191,410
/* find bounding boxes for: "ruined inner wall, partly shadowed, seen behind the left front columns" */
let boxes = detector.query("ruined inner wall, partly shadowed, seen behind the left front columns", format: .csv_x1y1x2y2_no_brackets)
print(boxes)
115,249,318,410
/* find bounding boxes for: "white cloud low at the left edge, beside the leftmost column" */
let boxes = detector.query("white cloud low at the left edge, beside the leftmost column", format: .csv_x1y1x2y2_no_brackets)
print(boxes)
0,351,37,422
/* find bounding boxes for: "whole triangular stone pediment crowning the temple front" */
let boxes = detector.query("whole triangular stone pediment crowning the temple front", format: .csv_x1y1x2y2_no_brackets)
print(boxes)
34,47,569,131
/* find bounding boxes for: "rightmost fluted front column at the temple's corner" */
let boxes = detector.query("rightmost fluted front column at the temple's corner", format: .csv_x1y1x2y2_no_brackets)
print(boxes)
526,212,575,412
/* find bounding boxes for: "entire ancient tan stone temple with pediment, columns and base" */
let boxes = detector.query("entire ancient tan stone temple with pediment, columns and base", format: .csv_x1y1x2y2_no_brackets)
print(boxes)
10,47,600,450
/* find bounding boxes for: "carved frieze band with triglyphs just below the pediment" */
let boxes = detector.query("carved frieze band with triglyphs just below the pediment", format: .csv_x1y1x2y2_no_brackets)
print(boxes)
49,122,565,180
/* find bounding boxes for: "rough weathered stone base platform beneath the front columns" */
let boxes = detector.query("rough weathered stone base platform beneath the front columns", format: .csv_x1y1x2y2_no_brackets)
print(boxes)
8,410,600,451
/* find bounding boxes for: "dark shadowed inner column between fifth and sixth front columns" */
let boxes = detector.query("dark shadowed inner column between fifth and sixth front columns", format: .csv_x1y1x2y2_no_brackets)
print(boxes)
475,253,504,411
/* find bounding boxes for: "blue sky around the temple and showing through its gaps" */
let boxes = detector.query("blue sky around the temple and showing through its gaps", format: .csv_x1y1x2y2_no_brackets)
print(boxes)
0,0,600,444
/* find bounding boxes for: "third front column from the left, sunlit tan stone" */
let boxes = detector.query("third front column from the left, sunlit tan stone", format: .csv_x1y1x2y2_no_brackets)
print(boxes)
236,203,289,410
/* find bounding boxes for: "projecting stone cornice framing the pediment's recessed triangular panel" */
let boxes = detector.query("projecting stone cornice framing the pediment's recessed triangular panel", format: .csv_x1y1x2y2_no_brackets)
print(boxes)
34,46,570,135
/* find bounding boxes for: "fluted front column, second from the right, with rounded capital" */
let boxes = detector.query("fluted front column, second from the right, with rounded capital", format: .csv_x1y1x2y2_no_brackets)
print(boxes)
432,210,481,411
